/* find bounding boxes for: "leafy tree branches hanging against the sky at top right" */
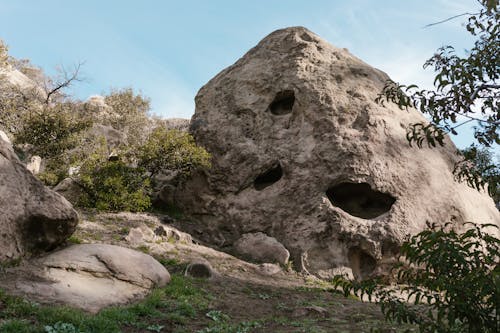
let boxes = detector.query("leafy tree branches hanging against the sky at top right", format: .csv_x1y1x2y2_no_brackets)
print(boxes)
377,0,500,147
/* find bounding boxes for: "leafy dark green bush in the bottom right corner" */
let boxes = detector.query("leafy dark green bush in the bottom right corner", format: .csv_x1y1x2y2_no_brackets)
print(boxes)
333,224,500,333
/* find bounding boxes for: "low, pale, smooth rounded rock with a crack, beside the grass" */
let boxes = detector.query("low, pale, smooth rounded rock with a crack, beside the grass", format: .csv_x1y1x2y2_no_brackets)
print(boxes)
1,244,170,312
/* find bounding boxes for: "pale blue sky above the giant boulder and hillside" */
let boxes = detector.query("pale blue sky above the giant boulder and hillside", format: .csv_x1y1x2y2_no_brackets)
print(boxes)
0,0,492,147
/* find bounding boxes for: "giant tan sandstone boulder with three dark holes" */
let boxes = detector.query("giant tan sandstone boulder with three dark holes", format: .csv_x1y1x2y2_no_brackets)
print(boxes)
175,27,500,278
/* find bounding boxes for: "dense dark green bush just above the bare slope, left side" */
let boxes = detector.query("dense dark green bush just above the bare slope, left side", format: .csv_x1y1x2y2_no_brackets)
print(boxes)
78,154,151,212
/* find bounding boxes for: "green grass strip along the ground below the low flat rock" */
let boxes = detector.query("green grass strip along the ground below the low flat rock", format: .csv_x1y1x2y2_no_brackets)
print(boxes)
0,275,212,333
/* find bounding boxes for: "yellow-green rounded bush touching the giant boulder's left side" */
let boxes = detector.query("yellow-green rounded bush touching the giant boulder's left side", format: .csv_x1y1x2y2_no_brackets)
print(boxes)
138,127,210,177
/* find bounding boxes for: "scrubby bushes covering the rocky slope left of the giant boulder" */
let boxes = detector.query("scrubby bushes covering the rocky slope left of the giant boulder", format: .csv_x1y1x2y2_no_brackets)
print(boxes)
0,43,210,212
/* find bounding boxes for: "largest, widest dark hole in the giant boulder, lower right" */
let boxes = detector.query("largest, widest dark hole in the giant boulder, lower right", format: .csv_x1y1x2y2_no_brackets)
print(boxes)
326,183,396,219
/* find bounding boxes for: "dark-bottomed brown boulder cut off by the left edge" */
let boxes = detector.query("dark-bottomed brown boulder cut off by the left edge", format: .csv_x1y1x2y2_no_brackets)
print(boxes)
0,140,78,261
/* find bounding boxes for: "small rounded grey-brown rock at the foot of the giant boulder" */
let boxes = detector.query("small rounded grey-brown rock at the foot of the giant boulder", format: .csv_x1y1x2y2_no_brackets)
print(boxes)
234,232,290,265
